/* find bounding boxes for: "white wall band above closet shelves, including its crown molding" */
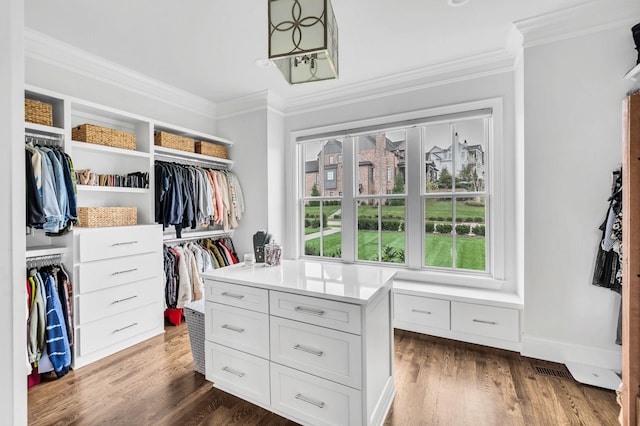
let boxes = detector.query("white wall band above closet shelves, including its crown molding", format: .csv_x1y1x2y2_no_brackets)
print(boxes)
25,29,216,135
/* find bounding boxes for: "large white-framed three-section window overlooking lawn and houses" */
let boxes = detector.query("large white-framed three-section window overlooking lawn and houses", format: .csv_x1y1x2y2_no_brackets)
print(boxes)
299,104,503,276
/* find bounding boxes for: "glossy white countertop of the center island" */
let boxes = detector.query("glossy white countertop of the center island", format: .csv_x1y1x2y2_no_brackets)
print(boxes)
201,259,395,305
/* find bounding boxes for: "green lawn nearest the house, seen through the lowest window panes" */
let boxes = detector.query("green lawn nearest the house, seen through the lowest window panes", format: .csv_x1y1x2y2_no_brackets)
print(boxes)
306,231,485,271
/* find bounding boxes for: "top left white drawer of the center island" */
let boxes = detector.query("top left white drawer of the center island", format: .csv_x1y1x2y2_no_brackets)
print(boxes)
204,280,269,314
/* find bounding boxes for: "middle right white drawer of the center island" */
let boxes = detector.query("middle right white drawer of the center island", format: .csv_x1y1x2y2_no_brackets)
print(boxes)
271,317,362,389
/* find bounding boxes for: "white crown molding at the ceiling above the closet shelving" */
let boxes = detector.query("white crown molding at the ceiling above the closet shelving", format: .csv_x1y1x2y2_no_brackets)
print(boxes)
25,27,216,119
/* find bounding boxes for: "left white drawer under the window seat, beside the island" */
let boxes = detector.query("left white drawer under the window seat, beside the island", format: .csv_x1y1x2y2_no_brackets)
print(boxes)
393,293,450,330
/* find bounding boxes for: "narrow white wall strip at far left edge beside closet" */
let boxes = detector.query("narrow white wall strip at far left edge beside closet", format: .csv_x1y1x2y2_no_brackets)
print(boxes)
0,0,27,425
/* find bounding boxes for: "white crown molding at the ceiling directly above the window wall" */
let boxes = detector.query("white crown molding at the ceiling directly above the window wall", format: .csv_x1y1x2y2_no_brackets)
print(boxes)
283,49,515,115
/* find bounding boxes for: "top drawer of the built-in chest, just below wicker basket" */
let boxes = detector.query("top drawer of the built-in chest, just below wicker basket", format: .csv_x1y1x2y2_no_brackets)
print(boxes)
78,225,162,262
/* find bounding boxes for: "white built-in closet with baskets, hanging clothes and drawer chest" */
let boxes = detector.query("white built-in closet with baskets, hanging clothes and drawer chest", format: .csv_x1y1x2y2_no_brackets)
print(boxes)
24,86,244,386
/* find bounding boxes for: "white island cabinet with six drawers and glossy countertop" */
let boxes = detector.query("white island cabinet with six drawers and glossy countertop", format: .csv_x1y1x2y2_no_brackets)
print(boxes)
204,260,395,425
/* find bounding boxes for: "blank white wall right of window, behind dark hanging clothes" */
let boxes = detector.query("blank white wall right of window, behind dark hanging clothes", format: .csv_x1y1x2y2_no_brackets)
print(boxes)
523,27,635,369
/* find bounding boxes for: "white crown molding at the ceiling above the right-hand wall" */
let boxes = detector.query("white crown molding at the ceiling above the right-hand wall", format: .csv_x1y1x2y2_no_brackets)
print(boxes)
514,0,640,48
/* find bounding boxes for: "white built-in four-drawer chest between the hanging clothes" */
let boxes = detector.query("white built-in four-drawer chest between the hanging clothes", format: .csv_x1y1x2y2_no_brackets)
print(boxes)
74,225,164,368
